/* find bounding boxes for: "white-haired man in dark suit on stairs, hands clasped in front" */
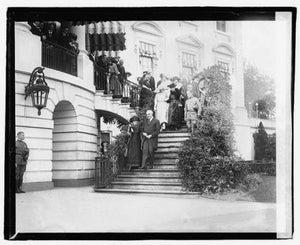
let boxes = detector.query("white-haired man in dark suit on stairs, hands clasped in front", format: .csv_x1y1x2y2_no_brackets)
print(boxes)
142,110,160,169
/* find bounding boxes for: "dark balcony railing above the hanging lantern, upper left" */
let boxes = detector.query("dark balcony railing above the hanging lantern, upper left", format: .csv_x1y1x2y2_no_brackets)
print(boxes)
42,41,77,76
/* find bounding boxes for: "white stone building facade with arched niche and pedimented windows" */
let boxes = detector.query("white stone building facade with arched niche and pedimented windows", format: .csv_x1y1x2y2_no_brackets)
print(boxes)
15,21,272,190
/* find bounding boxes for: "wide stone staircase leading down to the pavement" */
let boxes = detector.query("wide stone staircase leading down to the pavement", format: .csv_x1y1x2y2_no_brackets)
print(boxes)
95,127,190,194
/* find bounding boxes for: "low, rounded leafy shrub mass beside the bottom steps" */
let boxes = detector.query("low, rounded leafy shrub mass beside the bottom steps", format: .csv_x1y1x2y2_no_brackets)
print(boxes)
178,146,248,193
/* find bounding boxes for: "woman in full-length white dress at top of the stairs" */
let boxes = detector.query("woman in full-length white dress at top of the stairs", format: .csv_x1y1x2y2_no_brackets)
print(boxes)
154,81,170,130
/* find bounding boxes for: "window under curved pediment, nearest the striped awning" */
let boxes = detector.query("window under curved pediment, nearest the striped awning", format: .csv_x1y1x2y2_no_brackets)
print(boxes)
139,42,157,73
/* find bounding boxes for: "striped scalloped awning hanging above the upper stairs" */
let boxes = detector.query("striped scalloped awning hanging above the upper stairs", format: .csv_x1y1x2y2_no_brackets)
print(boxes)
88,21,126,53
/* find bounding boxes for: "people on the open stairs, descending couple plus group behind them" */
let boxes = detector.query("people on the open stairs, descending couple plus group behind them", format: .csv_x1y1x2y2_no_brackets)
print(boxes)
116,72,206,171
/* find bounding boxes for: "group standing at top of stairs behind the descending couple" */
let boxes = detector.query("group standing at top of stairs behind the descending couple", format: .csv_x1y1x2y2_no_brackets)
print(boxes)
139,72,206,131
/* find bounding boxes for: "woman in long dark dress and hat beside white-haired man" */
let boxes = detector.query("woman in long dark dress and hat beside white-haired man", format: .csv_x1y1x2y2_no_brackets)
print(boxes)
127,116,142,171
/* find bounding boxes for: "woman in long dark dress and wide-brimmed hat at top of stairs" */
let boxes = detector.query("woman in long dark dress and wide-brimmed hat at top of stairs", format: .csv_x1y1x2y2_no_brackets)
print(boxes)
167,83,182,130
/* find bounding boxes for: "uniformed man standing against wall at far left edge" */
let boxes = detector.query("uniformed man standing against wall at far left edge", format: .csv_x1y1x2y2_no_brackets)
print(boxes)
15,132,29,193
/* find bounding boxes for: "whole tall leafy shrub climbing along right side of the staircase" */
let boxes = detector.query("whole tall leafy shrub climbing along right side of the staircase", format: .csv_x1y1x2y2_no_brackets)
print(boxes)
178,66,250,193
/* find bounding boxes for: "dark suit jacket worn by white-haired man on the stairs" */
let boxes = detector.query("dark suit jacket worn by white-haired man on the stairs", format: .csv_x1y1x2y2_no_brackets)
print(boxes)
142,118,160,150
